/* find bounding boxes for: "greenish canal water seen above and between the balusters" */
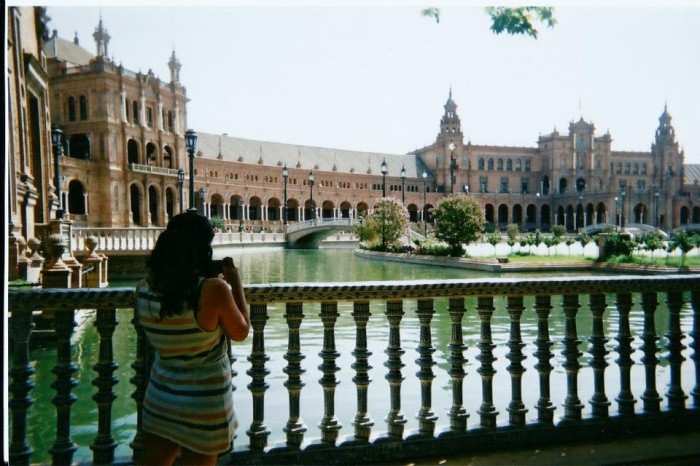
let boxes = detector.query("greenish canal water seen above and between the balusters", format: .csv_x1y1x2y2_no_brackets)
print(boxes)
20,249,692,462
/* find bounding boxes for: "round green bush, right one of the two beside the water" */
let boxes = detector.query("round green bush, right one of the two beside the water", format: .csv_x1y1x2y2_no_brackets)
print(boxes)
433,196,486,255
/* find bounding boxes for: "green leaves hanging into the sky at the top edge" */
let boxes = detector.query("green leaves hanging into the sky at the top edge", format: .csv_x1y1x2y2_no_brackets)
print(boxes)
421,6,557,39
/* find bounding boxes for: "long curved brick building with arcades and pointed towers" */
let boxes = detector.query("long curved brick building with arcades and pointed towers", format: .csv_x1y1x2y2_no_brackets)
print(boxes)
6,12,700,278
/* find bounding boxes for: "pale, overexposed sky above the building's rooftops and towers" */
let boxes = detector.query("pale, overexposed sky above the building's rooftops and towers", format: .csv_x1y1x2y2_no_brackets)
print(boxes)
20,0,700,163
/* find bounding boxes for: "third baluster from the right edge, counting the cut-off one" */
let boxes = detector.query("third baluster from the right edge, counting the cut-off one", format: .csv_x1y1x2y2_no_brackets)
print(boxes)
641,293,661,413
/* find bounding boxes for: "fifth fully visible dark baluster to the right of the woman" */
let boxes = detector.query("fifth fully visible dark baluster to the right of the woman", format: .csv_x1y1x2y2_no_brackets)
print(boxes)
384,301,406,440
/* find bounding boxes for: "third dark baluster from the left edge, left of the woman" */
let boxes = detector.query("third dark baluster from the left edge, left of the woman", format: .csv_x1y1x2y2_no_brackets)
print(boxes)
90,308,119,464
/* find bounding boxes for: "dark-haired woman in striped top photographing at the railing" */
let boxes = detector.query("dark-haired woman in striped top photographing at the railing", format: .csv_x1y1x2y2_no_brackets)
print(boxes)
136,211,250,465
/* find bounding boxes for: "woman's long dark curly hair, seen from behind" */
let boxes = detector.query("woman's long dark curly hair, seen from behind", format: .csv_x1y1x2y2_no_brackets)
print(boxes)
146,210,214,319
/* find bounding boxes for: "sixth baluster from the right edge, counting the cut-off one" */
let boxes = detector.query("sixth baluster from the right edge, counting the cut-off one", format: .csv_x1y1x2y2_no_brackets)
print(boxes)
562,294,583,421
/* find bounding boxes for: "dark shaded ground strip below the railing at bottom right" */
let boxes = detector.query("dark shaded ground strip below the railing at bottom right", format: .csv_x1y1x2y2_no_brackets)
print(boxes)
387,432,700,466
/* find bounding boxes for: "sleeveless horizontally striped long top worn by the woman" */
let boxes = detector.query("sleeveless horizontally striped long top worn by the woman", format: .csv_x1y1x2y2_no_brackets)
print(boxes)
136,279,236,455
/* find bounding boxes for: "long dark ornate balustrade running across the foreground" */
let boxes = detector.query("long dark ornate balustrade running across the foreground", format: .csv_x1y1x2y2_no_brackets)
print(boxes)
8,275,700,464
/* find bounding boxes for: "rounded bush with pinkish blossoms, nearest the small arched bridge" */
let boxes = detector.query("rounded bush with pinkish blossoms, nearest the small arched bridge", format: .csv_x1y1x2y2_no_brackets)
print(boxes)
355,197,408,251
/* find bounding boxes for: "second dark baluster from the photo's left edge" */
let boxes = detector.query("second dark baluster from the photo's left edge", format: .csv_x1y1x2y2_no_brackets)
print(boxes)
49,309,78,464
